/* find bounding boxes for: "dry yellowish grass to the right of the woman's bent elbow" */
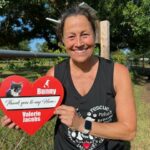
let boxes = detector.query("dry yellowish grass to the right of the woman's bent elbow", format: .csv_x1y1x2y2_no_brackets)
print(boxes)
131,81,150,150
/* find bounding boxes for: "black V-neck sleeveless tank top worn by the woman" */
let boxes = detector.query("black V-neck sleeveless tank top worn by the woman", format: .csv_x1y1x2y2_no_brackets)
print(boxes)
54,58,125,150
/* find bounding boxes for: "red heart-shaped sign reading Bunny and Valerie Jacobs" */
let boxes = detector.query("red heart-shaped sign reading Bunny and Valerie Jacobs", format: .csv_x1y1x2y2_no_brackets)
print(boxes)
0,75,64,135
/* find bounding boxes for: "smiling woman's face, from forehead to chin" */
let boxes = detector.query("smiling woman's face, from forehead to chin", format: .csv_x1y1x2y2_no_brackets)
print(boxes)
63,15,95,63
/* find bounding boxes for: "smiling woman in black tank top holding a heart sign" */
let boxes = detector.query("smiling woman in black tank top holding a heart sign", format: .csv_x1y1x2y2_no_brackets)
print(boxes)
2,7,136,150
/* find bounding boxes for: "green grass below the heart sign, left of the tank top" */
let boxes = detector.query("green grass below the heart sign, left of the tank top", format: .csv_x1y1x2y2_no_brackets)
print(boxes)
0,116,55,150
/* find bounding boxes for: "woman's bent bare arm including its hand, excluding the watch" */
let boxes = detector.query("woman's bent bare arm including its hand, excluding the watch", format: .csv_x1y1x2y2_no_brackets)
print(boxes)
56,64,136,141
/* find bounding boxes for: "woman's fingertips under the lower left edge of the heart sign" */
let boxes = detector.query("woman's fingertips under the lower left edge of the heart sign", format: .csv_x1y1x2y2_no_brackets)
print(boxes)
1,115,19,129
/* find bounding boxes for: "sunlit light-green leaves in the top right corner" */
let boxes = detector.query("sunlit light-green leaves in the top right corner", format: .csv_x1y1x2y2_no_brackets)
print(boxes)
123,0,150,36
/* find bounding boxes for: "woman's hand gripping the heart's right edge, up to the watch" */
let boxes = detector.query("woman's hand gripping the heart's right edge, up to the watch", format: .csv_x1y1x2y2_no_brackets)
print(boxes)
55,105,84,131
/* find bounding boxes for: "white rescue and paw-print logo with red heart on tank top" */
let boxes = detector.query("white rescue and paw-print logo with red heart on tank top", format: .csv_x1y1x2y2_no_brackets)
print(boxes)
68,105,113,150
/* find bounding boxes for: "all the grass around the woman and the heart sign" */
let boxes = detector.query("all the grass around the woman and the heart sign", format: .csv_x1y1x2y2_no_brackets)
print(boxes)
0,59,150,150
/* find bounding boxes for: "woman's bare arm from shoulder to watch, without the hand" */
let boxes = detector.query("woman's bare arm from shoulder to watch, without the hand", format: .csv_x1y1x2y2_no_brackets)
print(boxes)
88,64,136,140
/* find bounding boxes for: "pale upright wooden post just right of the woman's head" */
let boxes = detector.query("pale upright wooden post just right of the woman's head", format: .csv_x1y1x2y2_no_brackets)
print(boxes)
100,20,110,59
